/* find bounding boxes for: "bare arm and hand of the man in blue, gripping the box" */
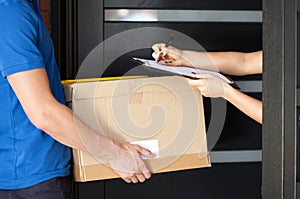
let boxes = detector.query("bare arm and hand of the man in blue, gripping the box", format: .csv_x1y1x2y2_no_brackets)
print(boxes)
7,69,153,183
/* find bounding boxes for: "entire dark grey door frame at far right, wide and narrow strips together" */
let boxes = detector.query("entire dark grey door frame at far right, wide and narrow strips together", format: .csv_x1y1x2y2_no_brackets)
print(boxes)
262,0,297,198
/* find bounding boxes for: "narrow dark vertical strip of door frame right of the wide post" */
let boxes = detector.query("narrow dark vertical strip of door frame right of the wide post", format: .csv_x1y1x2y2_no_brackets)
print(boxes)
283,0,297,198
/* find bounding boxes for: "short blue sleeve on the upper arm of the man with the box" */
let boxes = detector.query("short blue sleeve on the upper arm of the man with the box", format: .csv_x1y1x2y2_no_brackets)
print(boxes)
0,1,44,77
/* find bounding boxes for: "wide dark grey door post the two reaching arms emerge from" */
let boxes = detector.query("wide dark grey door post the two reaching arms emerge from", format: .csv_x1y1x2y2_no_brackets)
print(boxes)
262,0,284,199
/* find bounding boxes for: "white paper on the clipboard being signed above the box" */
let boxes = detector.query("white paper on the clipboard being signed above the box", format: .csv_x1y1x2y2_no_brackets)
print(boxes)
133,57,234,84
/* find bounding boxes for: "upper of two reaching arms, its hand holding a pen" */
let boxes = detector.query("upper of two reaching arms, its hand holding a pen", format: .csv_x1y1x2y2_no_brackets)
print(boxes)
152,44,262,76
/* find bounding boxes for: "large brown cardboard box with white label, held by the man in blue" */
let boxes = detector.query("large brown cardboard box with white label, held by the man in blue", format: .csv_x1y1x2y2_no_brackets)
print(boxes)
64,76,211,182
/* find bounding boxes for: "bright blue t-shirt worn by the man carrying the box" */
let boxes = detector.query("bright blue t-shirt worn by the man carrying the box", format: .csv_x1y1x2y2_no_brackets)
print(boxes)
0,0,71,189
